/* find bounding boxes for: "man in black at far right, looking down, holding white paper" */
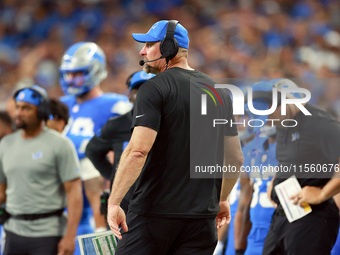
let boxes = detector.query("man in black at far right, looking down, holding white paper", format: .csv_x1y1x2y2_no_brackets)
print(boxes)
247,79,340,255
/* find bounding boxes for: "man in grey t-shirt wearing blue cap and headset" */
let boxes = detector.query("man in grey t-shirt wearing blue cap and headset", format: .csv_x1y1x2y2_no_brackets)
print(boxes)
0,86,82,255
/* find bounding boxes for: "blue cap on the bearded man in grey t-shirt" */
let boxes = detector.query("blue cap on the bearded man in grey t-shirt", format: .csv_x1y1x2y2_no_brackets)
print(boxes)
15,85,47,106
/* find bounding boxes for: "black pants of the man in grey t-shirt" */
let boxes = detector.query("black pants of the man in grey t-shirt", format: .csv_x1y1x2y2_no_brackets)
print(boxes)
4,231,61,255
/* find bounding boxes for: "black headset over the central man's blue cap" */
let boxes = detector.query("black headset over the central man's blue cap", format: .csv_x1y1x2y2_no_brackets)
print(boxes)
159,20,179,63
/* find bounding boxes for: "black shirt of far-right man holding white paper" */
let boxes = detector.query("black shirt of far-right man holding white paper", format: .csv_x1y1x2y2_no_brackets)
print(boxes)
272,104,340,203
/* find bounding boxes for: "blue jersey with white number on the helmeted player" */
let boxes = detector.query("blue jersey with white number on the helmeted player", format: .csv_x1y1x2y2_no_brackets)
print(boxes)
60,93,132,160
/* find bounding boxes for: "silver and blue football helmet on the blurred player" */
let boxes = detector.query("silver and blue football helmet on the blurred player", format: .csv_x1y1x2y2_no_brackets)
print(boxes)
59,42,107,96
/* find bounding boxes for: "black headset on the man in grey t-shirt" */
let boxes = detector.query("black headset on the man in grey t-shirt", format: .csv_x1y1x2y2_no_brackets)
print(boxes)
13,86,51,121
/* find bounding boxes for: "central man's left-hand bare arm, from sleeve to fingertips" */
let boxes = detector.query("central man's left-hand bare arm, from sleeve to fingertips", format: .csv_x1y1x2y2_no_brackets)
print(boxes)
107,126,157,239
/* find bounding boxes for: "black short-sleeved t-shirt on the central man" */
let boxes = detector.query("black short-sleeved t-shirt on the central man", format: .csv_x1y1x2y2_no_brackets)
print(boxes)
129,67,237,218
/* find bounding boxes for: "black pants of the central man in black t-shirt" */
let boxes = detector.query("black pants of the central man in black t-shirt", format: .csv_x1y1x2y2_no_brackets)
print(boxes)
116,212,217,255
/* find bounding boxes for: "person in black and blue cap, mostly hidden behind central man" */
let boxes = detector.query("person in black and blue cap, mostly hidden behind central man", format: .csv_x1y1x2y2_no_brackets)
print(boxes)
86,71,155,215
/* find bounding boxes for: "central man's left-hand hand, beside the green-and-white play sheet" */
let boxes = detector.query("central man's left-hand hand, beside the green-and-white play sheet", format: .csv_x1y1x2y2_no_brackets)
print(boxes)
107,205,128,240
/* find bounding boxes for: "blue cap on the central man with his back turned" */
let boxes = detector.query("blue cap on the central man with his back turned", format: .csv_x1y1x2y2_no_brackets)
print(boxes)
132,20,189,49
